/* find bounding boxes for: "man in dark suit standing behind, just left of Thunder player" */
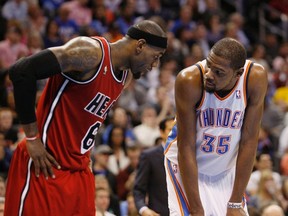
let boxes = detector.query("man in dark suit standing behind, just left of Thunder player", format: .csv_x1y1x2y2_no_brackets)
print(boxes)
133,117,174,215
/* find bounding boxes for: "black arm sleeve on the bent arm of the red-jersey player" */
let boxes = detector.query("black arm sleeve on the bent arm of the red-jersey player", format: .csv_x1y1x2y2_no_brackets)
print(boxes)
9,49,61,124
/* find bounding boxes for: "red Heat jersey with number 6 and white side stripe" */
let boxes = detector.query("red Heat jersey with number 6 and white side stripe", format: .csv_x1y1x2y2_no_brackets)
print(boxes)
37,37,128,170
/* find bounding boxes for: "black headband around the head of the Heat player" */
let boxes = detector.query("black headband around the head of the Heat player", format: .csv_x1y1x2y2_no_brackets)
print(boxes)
127,26,167,49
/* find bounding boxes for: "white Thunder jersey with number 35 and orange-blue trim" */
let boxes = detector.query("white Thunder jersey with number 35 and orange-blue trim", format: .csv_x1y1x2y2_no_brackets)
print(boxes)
165,60,252,176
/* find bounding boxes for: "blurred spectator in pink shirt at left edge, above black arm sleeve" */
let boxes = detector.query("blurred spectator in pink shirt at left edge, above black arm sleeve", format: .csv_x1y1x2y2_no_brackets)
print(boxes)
0,23,28,68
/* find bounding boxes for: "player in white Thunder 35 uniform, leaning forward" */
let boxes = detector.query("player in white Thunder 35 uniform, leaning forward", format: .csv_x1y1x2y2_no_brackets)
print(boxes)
165,38,267,216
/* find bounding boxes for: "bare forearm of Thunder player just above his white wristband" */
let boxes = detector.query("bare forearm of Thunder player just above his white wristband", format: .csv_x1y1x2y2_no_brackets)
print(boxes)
229,141,257,203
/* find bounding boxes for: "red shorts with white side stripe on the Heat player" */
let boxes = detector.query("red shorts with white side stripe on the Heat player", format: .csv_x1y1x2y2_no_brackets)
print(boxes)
4,141,95,216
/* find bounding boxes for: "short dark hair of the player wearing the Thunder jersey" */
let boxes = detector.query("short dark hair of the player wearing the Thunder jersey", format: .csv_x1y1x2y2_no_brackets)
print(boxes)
211,37,247,70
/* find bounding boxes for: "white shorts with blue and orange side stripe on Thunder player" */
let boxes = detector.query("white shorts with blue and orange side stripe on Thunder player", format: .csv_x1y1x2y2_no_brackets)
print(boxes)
165,158,249,216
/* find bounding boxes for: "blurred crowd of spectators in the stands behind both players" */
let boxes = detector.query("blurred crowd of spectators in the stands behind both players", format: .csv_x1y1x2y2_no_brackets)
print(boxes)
0,0,288,216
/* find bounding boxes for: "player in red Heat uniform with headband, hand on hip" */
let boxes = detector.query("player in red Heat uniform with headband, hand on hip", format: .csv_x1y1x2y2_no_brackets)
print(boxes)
5,20,167,216
